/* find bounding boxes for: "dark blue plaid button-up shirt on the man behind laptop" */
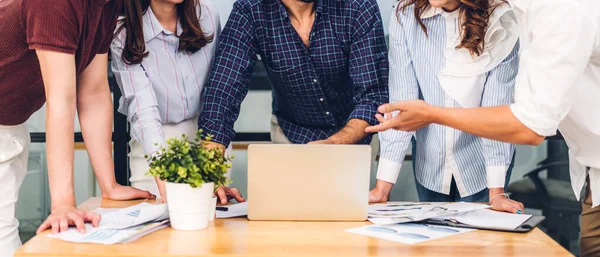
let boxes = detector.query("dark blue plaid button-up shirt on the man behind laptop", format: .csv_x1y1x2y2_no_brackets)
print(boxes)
198,0,388,145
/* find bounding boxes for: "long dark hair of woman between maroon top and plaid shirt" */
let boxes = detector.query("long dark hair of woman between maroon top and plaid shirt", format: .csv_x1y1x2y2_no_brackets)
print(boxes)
116,0,213,64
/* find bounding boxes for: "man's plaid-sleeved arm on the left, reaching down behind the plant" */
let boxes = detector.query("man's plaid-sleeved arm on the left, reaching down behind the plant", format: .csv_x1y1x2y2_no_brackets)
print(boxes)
198,1,257,151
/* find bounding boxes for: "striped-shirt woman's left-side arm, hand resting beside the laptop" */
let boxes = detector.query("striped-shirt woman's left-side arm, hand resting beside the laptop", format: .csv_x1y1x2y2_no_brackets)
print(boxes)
369,9,419,202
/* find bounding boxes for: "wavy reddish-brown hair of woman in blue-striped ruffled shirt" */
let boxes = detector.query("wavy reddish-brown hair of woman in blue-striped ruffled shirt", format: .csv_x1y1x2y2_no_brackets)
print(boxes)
398,0,499,56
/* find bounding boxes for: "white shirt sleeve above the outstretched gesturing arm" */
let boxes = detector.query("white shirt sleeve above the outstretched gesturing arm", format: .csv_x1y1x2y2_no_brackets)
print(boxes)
510,0,598,136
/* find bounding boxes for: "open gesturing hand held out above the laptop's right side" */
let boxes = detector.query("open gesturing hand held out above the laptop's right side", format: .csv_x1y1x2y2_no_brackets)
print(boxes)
365,100,433,133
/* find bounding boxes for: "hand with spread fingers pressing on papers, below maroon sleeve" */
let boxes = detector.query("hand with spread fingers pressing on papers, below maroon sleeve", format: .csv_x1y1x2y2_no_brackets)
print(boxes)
36,205,100,234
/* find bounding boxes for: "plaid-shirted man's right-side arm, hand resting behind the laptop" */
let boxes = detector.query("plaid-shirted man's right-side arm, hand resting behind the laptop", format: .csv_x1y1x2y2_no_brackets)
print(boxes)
312,0,389,144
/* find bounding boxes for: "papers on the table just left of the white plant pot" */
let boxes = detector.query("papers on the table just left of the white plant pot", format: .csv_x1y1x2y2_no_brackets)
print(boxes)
48,203,169,245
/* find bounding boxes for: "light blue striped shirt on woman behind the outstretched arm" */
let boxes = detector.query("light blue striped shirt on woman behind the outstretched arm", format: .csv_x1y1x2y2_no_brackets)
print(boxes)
377,3,519,197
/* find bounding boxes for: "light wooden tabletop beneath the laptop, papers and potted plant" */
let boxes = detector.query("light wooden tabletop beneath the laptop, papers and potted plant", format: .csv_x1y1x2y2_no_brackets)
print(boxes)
15,198,572,257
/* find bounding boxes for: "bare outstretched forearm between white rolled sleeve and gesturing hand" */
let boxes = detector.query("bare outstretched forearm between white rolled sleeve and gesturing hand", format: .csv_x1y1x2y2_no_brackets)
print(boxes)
430,106,544,145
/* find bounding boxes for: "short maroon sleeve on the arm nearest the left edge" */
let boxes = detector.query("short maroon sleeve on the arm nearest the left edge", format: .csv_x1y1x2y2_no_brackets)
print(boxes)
23,0,83,54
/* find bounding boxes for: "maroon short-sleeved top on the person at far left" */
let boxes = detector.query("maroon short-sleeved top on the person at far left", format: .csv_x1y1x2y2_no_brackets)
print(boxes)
0,0,122,125
